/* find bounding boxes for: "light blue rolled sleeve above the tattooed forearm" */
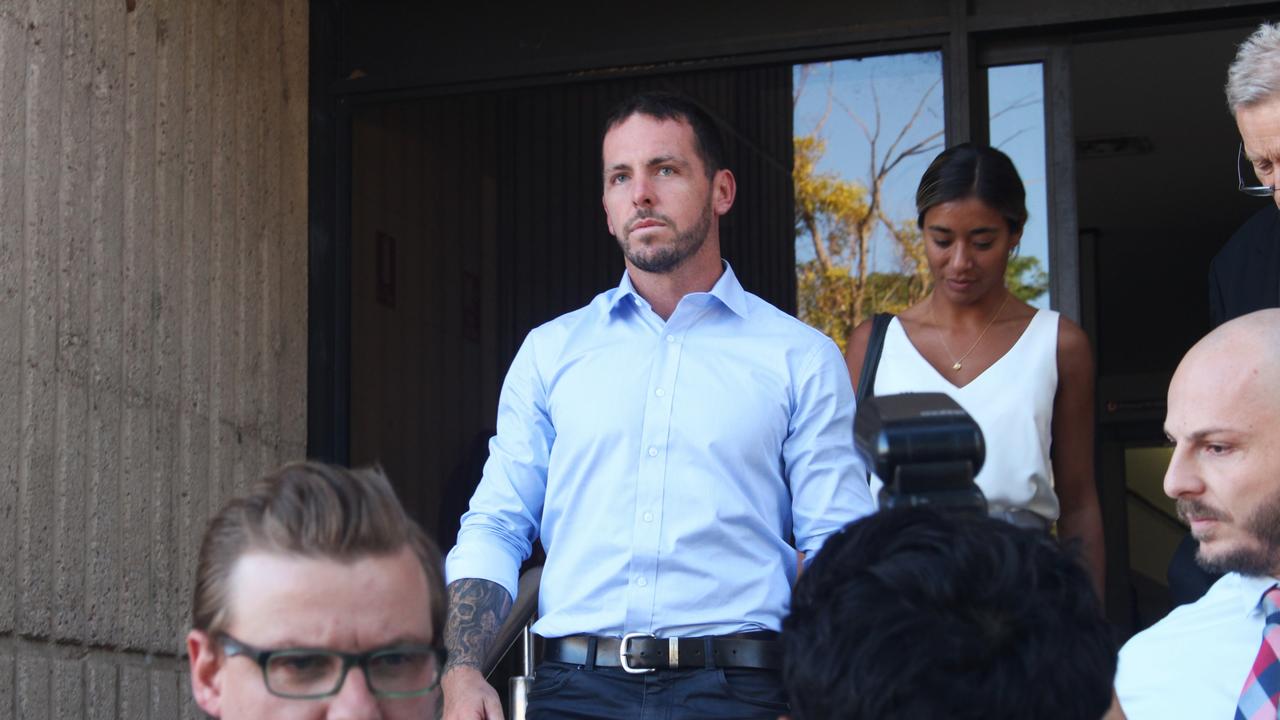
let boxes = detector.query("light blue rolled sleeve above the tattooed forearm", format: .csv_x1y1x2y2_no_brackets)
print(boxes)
444,331,556,598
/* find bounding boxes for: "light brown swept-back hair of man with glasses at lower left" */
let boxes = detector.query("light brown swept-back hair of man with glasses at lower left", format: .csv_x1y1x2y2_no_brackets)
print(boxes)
191,461,444,634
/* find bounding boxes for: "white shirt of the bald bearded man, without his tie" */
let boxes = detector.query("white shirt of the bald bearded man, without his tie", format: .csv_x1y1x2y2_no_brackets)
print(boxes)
1116,573,1276,720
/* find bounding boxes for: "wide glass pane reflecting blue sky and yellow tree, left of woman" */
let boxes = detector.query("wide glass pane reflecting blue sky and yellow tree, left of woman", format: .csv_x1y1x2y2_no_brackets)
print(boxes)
792,51,943,350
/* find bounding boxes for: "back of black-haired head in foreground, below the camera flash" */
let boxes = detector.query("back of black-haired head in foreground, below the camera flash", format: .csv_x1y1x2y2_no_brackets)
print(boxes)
782,509,1116,720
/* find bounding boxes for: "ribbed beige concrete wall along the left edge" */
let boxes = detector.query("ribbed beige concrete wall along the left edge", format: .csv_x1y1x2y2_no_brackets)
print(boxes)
0,0,308,720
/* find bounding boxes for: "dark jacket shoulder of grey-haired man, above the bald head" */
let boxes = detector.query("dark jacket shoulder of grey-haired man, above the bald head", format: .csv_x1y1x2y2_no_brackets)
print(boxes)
1208,202,1280,328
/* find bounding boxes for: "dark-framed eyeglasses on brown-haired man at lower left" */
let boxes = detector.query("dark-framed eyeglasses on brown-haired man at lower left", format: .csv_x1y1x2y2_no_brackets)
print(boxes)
220,633,444,700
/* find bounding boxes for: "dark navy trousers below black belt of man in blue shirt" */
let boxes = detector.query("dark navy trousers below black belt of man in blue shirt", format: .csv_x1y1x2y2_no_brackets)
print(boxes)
527,662,790,720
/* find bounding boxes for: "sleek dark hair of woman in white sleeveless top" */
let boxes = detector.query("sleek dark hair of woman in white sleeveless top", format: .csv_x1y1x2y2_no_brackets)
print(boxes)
915,142,1027,233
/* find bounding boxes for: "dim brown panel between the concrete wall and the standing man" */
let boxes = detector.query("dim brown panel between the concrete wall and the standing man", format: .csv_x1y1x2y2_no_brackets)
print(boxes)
351,96,499,539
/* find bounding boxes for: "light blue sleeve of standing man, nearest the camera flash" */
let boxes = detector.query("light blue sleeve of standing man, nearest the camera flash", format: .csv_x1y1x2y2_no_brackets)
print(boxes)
782,338,874,562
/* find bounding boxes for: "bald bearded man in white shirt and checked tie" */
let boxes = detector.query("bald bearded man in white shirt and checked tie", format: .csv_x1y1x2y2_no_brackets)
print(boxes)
1116,309,1280,720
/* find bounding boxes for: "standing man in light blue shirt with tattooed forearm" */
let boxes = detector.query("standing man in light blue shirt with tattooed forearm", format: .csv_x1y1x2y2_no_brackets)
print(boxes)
443,94,872,719
